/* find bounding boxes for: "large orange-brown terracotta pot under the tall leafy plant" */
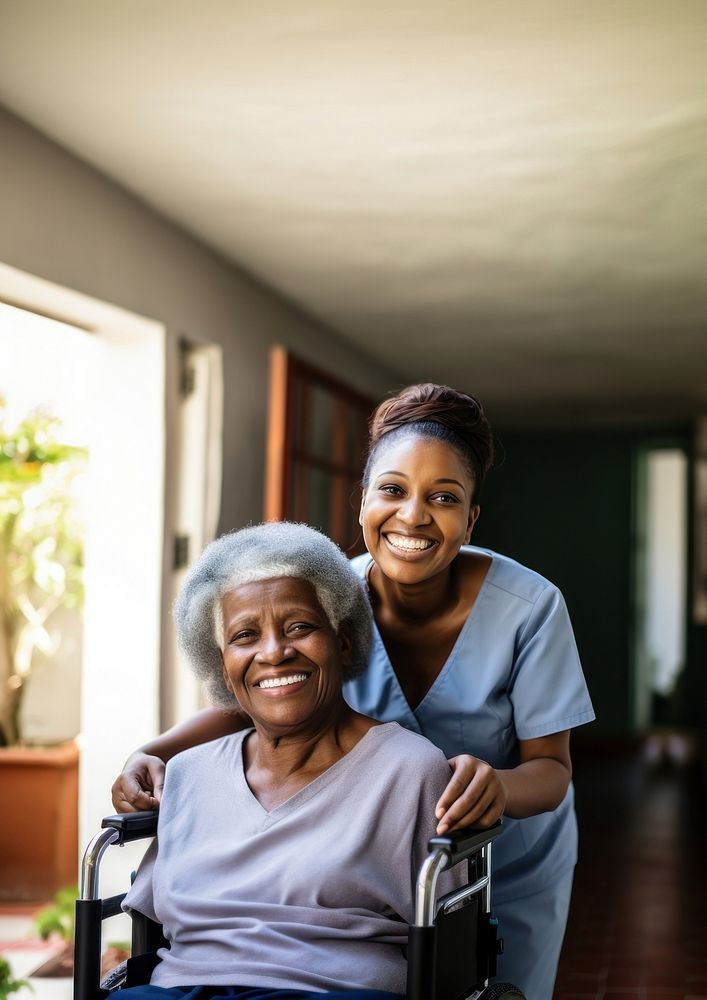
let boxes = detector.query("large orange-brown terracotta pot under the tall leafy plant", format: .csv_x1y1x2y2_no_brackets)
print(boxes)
0,742,79,902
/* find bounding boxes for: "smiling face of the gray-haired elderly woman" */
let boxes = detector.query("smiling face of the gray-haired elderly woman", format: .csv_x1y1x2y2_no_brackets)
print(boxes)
221,577,350,736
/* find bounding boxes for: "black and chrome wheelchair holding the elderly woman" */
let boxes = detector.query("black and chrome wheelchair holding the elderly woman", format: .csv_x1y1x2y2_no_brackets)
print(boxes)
74,811,524,1000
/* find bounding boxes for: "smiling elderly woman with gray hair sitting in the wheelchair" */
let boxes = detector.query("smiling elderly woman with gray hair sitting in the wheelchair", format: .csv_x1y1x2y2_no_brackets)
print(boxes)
79,524,518,1000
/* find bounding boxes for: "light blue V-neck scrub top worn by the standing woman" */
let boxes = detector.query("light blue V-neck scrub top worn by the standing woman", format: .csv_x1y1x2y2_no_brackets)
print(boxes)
344,546,594,903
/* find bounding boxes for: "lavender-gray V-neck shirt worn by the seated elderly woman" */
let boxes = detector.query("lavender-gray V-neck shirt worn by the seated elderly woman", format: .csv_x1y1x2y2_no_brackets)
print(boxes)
125,723,463,993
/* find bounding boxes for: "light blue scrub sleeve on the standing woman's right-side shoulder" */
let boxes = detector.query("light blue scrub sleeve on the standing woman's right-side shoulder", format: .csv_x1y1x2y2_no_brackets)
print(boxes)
509,584,594,740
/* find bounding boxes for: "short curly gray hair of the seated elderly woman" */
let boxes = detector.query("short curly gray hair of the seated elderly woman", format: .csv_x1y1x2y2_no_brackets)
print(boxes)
174,521,371,708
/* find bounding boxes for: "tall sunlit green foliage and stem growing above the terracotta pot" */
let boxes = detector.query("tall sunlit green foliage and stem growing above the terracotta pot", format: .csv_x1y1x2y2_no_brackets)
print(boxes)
0,397,86,746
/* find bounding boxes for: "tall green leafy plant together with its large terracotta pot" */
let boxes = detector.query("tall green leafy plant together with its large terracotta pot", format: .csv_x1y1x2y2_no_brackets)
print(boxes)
0,399,86,899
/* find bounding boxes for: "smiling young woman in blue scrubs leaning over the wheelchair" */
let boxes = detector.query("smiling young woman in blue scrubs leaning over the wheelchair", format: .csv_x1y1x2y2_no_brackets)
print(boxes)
113,383,594,1000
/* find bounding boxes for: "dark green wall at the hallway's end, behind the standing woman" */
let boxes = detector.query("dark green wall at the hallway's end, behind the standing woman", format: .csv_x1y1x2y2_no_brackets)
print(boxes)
473,430,705,736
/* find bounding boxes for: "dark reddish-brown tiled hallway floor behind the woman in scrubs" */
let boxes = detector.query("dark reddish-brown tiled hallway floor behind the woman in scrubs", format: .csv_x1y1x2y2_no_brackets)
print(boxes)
555,733,707,1000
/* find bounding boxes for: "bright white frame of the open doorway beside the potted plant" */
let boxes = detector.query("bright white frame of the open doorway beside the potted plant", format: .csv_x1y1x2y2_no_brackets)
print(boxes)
0,265,166,895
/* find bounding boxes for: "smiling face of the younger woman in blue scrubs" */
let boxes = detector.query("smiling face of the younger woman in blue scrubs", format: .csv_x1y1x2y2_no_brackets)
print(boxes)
359,436,479,584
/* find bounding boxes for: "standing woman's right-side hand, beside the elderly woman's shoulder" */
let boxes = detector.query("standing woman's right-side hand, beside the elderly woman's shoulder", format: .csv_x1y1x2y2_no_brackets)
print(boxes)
435,754,508,834
